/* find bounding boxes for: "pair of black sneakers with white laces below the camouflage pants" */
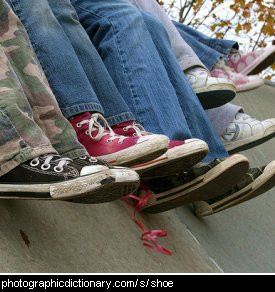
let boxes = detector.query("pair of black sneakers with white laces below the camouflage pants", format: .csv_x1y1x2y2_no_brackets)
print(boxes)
0,155,139,203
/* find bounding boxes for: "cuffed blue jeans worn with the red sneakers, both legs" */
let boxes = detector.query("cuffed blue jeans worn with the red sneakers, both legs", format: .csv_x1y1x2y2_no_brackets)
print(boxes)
7,0,134,125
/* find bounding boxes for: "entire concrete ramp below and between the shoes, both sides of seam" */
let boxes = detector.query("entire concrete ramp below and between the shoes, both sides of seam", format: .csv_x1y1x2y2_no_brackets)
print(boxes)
0,82,275,273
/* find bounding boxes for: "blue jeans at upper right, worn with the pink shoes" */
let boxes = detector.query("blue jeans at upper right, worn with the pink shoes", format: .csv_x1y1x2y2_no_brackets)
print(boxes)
173,21,238,70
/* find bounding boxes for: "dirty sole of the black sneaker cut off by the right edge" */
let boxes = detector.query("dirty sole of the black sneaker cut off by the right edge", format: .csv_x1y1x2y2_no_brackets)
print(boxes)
194,162,275,217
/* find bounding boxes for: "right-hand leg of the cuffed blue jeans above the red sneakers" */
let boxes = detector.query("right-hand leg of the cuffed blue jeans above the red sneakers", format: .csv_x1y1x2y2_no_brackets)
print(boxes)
48,0,135,125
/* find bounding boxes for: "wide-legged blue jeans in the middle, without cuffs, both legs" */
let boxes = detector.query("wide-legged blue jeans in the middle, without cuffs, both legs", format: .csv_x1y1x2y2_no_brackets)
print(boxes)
71,0,227,160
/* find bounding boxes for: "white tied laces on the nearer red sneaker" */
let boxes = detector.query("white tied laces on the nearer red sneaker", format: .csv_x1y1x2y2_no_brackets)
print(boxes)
78,114,127,144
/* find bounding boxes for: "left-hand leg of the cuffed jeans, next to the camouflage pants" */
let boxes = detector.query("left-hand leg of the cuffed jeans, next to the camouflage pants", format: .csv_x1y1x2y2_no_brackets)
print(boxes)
7,0,103,118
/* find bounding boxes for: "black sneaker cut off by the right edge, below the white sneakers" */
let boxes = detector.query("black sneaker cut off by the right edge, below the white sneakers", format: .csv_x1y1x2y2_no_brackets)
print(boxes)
193,161,275,217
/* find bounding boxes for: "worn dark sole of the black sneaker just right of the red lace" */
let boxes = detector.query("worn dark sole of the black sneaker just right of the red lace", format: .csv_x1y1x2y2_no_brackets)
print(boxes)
142,155,249,213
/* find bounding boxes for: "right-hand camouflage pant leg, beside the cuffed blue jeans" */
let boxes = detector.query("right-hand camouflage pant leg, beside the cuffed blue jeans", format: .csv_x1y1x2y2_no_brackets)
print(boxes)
0,1,86,158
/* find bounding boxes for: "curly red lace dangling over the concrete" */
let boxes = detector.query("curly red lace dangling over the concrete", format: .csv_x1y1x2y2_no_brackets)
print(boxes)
121,185,172,256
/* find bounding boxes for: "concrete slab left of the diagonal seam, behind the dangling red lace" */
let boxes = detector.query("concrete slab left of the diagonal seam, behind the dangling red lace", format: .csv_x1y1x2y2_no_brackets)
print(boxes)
0,201,219,273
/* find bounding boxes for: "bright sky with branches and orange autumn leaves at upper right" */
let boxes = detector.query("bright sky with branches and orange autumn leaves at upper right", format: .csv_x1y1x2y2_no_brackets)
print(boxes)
158,0,275,81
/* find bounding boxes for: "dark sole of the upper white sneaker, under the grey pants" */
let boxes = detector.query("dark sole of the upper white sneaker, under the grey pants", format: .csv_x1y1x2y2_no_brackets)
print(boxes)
197,90,236,110
